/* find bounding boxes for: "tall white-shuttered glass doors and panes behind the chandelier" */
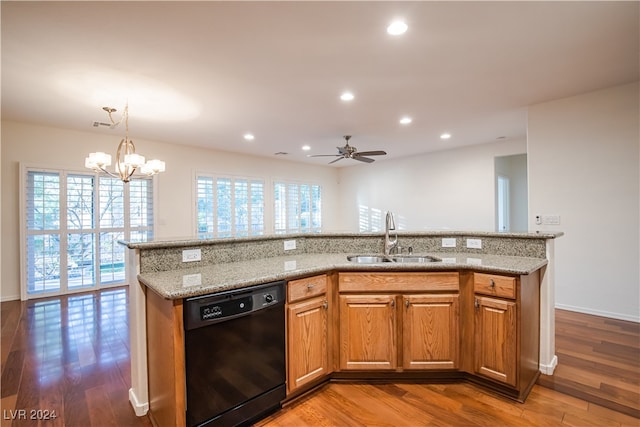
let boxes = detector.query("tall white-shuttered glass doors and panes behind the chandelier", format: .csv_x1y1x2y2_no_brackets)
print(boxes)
23,168,153,298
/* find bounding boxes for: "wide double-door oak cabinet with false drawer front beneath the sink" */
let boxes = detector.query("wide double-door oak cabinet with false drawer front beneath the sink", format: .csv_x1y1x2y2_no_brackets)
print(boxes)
339,272,459,370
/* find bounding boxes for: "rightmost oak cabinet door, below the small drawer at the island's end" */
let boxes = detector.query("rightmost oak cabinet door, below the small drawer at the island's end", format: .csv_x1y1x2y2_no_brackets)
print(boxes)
475,296,517,387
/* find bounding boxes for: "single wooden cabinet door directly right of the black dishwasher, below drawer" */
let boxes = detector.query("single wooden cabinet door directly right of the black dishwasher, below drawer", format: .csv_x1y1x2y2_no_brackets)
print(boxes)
287,296,329,392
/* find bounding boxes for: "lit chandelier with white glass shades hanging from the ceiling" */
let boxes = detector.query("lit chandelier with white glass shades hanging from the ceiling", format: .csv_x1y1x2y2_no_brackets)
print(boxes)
84,104,164,182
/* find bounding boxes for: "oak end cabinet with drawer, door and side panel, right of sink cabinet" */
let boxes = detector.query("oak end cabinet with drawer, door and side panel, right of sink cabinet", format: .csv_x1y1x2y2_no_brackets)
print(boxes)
473,272,540,399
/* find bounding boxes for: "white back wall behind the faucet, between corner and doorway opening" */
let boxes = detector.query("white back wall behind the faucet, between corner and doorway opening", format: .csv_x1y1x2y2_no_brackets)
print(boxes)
339,140,526,231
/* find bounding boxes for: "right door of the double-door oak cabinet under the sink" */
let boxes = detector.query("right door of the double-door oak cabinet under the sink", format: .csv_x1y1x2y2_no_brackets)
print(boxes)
402,294,459,369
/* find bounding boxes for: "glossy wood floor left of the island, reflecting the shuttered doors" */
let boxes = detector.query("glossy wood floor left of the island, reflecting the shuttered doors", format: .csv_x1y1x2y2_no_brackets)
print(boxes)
0,288,151,426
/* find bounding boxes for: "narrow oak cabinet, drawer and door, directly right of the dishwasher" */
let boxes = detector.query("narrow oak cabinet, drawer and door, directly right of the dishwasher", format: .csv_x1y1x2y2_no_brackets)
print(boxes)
287,274,330,393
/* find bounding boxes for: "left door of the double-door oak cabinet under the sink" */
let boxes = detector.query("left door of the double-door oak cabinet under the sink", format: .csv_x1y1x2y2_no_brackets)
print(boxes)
340,295,397,370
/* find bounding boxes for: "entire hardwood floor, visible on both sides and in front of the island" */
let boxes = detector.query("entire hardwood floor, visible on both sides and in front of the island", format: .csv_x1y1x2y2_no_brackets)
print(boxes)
0,288,640,427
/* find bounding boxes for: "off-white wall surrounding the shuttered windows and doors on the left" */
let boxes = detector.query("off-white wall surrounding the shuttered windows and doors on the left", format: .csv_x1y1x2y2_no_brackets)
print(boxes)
0,122,339,300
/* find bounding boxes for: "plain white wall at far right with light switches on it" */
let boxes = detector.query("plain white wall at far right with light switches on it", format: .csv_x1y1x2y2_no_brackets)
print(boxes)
527,83,640,321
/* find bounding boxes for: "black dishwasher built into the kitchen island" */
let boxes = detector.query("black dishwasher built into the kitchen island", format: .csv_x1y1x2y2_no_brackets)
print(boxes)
184,281,286,426
